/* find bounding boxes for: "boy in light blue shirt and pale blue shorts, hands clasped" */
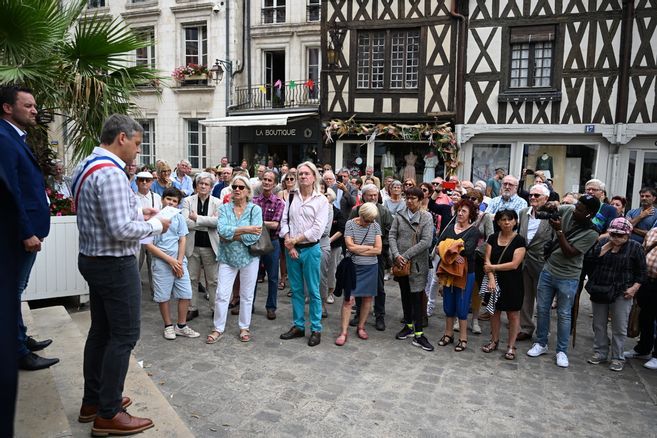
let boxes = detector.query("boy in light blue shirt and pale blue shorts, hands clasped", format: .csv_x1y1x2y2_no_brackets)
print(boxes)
146,187,199,340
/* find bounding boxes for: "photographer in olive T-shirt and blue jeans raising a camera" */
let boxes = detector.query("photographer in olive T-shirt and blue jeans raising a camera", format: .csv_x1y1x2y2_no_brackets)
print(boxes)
527,195,600,368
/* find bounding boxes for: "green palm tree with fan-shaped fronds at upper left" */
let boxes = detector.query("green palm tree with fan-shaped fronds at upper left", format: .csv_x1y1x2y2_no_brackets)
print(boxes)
0,0,161,160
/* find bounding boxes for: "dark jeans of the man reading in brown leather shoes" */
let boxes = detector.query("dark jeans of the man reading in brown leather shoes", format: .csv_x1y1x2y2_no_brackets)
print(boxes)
78,254,141,418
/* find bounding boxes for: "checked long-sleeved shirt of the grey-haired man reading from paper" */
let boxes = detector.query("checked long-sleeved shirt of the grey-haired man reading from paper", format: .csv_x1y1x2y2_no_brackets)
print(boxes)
73,147,162,257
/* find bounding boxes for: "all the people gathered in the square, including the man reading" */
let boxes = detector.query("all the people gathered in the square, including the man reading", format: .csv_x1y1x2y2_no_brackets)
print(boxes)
0,84,657,434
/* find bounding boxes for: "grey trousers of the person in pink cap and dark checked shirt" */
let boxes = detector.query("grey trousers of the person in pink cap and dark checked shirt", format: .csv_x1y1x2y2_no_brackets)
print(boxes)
591,296,632,360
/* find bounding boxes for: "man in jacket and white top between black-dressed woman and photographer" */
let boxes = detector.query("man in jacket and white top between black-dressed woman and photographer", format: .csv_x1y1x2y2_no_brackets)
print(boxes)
518,184,553,341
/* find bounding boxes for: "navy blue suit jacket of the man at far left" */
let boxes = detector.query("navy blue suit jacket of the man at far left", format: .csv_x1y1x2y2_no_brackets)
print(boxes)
0,119,50,240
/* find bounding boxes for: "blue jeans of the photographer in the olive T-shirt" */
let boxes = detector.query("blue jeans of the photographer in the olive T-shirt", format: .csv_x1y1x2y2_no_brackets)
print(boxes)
536,269,579,354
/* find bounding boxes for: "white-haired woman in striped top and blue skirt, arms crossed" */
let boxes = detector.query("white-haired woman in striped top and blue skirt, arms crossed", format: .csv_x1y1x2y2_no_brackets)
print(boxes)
335,202,383,346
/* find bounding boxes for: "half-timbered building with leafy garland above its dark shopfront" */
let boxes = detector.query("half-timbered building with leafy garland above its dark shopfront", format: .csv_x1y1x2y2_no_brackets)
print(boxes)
321,0,459,181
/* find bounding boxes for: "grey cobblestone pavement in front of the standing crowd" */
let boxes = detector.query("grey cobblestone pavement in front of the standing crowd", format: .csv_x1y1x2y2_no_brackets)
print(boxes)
134,281,657,437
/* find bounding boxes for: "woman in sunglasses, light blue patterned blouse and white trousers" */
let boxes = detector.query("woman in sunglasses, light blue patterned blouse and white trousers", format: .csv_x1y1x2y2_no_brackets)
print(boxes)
206,175,262,344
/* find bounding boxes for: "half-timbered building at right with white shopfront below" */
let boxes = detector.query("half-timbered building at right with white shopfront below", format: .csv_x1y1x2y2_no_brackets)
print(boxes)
456,0,657,206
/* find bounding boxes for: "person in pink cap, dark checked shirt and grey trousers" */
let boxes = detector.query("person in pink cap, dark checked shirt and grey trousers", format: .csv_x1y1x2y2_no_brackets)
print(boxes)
586,217,646,371
